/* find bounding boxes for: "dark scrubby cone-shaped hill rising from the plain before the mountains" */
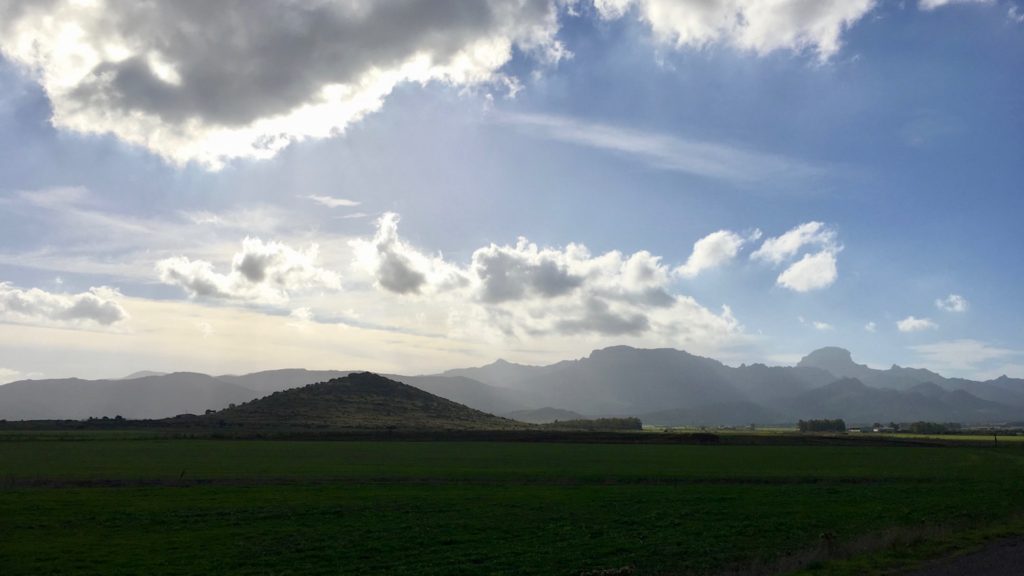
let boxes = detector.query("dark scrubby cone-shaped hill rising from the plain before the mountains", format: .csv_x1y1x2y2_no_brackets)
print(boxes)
208,372,520,429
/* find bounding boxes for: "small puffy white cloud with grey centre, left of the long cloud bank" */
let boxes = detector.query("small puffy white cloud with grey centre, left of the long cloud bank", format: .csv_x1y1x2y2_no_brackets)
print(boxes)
156,237,341,304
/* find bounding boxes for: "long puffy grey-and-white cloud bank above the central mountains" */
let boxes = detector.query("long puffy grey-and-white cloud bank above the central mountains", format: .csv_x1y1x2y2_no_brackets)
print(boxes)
353,213,742,347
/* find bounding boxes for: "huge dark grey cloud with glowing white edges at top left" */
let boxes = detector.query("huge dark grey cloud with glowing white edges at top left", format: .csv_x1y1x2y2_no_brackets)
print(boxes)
0,0,566,168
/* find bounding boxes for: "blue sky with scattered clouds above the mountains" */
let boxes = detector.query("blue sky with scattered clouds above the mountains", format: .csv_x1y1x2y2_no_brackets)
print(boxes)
0,0,1024,382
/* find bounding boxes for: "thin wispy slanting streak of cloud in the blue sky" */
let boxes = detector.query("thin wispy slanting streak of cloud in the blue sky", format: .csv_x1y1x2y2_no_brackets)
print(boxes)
495,114,820,184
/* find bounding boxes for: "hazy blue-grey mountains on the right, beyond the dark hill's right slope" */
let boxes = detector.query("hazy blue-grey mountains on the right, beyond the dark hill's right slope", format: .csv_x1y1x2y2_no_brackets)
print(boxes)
434,346,1024,424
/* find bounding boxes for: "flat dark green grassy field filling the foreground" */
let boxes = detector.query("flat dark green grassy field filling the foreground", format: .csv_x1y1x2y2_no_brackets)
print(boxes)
0,434,1024,575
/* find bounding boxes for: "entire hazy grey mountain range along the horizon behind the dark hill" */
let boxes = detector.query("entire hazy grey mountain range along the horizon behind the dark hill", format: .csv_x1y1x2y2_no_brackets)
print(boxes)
0,346,1024,425
